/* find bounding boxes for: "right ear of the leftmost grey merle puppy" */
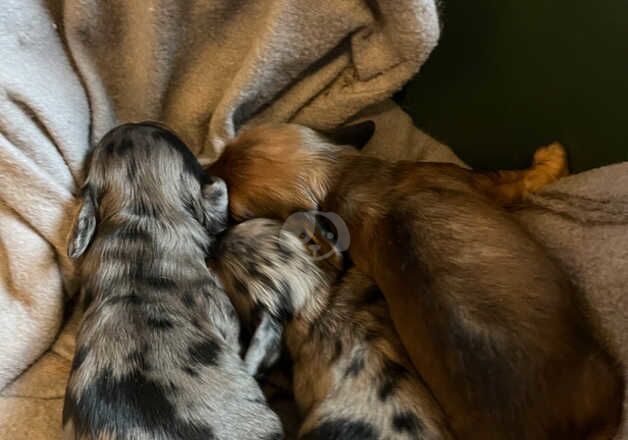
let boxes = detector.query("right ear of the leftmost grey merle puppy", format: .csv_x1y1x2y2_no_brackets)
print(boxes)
200,176,229,235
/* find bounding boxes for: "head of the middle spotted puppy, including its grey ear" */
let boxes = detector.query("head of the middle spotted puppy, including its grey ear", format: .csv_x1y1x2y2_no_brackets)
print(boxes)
209,218,328,375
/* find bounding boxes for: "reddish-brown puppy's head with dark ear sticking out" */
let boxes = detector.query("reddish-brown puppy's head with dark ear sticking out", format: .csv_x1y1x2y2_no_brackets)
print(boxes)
207,121,375,220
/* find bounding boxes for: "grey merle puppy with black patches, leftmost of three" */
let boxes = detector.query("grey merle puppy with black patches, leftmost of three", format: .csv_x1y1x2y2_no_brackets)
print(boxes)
63,123,282,440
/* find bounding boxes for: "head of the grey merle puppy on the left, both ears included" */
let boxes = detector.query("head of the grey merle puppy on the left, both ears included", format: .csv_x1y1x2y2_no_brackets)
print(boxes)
68,122,228,258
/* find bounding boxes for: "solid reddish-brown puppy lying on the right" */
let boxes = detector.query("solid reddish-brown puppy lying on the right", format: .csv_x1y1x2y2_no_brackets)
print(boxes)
209,124,623,439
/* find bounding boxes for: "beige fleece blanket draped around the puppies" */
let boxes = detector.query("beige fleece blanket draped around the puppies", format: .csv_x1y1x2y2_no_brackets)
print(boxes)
0,0,628,440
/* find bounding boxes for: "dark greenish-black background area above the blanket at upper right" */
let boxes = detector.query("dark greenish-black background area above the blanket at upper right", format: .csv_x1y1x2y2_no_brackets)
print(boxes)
395,0,628,171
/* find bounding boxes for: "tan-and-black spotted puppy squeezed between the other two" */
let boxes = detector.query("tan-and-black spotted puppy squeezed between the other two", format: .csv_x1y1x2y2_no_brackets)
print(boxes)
212,219,451,440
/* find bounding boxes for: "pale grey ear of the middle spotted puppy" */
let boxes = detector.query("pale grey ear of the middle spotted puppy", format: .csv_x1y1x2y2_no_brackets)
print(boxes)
244,311,283,376
